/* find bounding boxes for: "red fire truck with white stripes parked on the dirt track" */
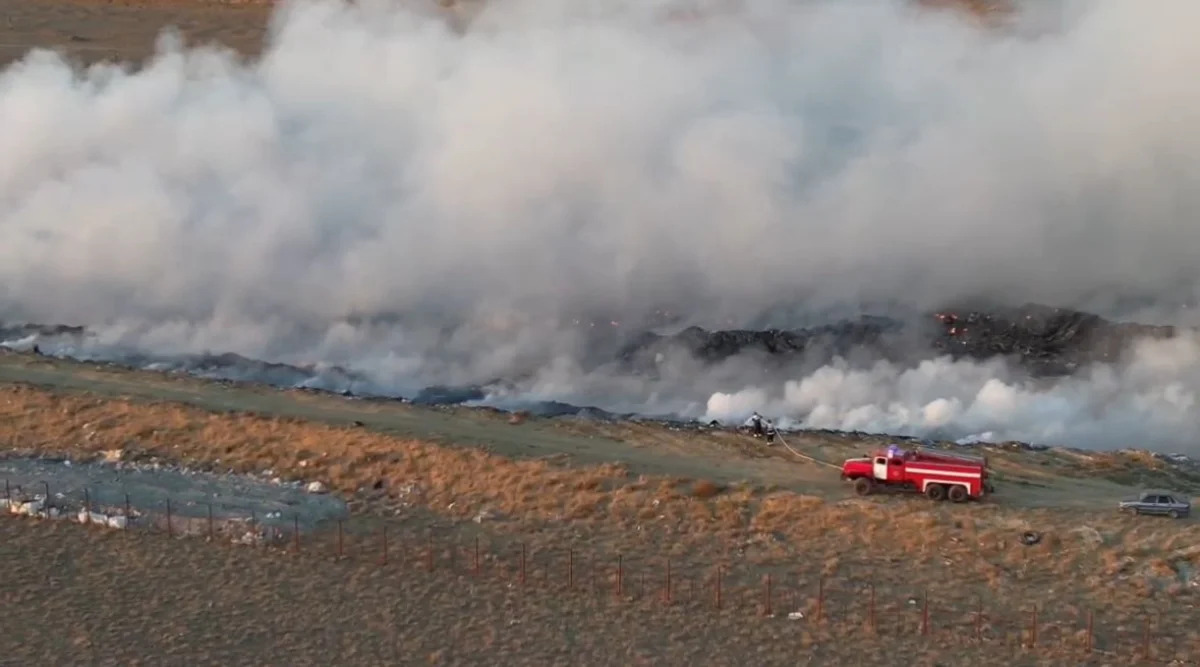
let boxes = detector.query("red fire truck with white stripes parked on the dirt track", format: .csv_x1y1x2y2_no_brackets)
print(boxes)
841,446,994,503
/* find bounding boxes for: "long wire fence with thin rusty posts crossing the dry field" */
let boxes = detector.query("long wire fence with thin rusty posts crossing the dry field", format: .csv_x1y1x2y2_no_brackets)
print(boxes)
0,481,1200,665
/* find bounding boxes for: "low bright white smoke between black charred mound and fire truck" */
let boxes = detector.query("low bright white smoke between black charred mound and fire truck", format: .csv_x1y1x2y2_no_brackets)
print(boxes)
706,335,1200,452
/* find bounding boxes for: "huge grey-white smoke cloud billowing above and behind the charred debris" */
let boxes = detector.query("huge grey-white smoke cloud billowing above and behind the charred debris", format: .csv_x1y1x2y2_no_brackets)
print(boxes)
0,0,1200,445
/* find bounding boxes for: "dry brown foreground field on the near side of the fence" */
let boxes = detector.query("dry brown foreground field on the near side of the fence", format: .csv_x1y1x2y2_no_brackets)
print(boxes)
0,519,1182,667
